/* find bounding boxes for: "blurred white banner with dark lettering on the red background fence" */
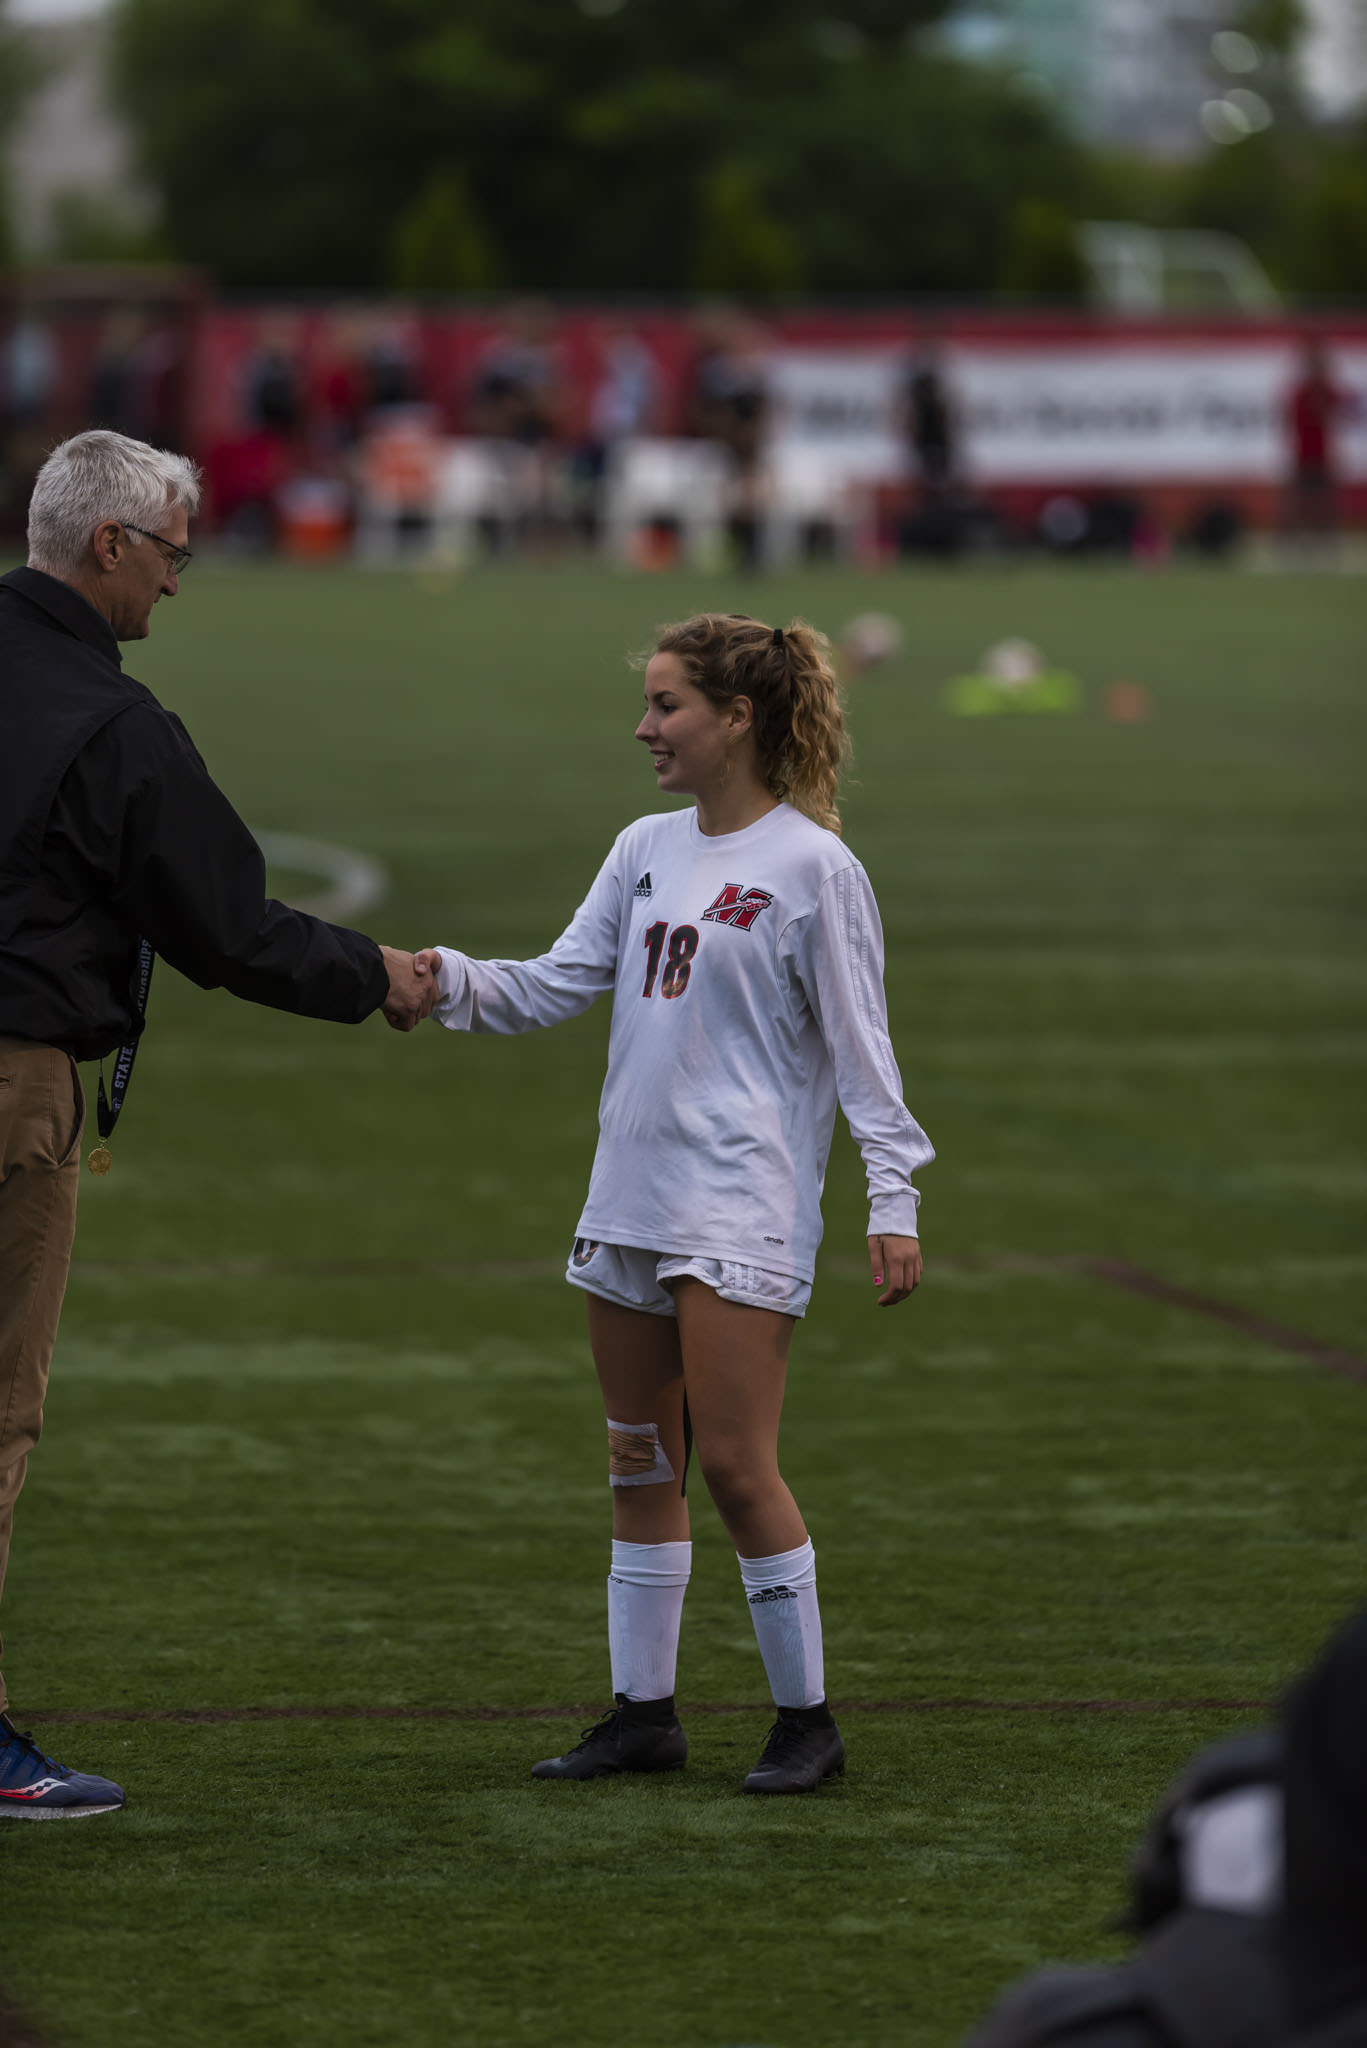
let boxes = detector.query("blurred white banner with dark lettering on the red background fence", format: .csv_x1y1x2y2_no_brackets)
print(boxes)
771,340,1367,489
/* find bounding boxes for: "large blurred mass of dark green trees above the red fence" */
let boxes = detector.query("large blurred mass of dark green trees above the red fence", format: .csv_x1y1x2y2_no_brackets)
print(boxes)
115,0,1086,291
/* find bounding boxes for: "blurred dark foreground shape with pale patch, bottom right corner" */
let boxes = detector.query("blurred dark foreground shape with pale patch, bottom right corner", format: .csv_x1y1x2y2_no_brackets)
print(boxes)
963,1612,1367,2048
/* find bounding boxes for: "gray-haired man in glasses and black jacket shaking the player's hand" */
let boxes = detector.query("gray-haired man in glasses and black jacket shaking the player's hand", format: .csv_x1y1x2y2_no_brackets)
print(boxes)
0,430,434,1821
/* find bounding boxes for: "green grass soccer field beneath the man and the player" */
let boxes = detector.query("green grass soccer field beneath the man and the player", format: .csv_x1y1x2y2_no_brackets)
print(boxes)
0,565,1367,2048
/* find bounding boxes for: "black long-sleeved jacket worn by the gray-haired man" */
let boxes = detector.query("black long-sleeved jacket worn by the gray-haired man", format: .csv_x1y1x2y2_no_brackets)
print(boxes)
0,569,389,1059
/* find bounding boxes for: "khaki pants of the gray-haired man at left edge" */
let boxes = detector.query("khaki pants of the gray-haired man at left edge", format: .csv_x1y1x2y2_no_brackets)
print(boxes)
0,1034,86,1712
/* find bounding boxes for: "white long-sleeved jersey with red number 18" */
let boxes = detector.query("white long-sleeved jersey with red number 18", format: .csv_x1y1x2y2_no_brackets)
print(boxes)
434,805,935,1280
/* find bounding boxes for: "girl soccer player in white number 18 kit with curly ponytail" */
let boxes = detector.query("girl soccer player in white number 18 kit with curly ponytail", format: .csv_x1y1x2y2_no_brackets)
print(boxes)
420,612,935,1792
